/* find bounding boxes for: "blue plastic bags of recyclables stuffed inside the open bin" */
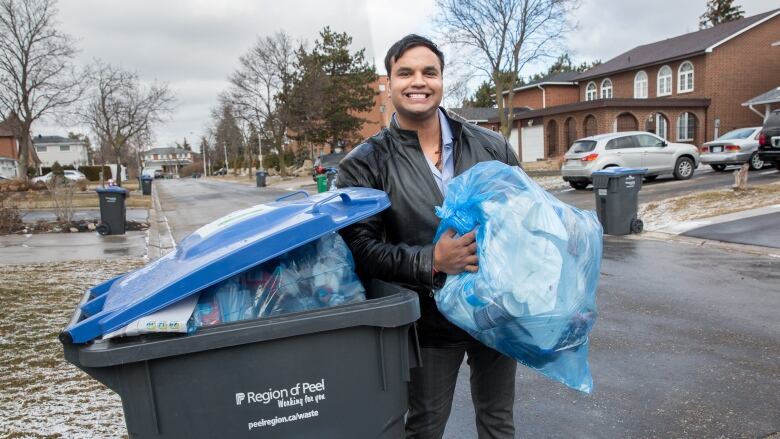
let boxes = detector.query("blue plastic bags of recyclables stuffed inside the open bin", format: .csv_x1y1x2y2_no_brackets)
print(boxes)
189,232,366,331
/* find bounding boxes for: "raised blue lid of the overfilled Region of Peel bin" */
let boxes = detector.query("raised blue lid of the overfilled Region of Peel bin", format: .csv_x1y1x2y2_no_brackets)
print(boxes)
64,188,390,343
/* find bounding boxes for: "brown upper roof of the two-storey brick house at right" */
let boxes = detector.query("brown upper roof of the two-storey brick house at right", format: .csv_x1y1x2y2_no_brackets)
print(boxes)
579,9,780,80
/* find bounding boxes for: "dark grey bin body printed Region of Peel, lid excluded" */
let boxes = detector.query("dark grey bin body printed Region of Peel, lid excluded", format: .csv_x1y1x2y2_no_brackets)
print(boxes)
64,281,420,439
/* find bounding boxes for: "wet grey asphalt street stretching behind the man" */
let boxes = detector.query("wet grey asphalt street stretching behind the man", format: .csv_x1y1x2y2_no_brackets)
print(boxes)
157,176,780,439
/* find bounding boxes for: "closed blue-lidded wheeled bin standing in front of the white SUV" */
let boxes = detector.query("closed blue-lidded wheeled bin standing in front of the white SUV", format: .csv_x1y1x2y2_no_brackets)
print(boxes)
592,168,647,235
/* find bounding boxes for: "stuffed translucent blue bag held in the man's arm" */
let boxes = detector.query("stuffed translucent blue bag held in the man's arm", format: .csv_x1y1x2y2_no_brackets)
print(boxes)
434,161,602,393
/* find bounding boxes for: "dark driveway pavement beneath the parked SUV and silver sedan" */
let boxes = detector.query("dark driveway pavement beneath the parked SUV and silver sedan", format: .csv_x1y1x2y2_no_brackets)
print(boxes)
552,166,780,209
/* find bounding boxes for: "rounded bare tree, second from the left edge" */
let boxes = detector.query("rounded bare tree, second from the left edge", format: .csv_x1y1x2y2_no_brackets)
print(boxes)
81,61,175,185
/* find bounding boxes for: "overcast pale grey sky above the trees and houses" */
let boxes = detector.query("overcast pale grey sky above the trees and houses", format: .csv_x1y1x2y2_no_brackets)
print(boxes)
38,0,778,150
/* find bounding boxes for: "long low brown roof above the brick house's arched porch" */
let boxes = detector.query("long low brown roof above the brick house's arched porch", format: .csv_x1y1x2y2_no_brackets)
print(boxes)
508,98,710,120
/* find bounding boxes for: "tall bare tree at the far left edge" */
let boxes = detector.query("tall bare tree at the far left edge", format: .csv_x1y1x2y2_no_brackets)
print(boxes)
0,0,82,178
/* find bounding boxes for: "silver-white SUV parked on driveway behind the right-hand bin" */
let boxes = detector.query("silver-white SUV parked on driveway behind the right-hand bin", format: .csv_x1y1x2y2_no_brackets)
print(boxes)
561,131,699,189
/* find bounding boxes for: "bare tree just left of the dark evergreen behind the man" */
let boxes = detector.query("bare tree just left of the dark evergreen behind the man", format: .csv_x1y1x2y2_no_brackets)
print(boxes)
225,32,295,176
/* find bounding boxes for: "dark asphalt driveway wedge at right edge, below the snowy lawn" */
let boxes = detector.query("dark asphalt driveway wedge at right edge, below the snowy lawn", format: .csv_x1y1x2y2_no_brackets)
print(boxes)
683,212,780,248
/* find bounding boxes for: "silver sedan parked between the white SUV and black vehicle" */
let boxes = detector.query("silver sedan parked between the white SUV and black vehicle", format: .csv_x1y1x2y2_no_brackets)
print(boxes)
699,127,764,171
